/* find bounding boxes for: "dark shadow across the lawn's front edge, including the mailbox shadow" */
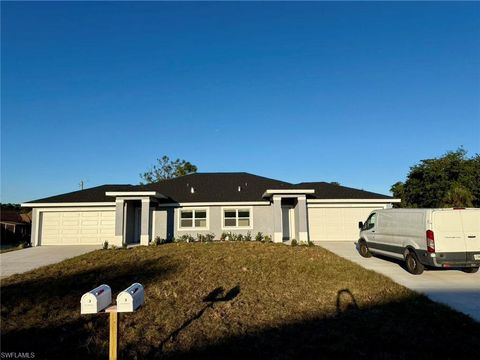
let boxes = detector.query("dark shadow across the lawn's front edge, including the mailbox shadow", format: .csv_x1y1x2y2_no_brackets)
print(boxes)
2,288,480,359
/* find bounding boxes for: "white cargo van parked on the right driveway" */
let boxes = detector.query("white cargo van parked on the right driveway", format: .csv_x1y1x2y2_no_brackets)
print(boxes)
358,209,480,275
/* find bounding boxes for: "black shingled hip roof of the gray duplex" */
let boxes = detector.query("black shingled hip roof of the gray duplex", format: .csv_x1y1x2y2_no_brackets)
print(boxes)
22,172,392,203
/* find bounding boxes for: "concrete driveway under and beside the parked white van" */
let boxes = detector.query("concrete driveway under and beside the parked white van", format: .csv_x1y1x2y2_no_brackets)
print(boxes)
318,241,480,321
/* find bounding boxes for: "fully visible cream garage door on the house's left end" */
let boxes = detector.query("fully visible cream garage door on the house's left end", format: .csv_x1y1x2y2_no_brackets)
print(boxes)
40,210,115,245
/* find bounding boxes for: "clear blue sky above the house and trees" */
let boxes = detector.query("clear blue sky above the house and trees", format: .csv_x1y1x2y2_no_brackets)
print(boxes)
1,2,480,202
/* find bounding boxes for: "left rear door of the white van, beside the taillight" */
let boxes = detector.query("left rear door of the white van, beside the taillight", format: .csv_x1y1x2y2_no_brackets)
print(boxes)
432,210,467,262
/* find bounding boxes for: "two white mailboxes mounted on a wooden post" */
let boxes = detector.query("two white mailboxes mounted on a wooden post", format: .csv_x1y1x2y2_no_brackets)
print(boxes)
80,283,144,360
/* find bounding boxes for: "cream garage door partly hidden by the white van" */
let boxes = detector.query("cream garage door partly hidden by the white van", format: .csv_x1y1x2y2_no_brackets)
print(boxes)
308,207,382,241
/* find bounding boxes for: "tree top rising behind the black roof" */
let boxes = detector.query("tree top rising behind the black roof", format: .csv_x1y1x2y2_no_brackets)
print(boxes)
140,156,197,185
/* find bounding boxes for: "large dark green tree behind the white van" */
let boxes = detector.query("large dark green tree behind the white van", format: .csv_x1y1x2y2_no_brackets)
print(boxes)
390,148,480,208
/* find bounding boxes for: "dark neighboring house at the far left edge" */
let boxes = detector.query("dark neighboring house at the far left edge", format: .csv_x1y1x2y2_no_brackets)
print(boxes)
0,208,32,244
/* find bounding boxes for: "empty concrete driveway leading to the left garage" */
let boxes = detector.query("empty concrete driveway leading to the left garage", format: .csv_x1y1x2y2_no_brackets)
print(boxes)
0,245,101,278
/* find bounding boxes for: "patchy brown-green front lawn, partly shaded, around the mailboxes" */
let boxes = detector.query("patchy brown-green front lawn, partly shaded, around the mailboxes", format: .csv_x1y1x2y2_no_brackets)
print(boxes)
1,242,480,359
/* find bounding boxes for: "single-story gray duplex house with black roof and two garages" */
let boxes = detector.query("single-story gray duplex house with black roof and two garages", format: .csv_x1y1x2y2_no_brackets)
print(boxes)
22,173,400,246
